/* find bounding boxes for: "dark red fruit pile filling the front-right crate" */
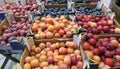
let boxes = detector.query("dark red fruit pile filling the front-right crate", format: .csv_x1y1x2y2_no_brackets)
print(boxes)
82,33,120,67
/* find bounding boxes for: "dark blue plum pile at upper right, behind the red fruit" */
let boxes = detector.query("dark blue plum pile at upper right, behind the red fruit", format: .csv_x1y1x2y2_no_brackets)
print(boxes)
75,6,104,16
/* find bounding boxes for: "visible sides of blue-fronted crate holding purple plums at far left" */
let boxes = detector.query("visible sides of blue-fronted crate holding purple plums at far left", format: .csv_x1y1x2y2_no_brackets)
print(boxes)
0,19,24,54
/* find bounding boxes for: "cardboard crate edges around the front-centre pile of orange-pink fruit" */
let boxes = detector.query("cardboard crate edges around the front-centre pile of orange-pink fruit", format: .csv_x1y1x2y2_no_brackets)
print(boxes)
20,38,84,68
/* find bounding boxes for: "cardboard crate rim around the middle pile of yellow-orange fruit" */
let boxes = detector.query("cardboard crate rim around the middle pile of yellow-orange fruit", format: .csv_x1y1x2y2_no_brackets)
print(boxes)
27,15,82,40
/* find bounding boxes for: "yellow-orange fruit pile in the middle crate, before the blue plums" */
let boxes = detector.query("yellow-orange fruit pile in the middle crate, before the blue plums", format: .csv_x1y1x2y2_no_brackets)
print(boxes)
32,16,78,39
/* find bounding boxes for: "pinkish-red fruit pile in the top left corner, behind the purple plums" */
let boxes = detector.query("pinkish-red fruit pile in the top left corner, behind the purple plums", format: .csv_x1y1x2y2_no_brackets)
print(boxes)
2,4,39,16
